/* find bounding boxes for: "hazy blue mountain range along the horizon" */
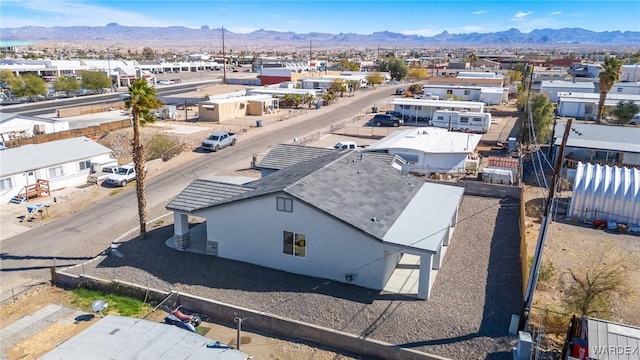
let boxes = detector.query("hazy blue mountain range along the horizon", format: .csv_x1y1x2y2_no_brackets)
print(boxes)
0,23,640,50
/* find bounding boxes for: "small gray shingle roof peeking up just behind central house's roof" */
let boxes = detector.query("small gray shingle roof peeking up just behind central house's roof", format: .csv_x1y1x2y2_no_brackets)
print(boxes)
257,144,337,170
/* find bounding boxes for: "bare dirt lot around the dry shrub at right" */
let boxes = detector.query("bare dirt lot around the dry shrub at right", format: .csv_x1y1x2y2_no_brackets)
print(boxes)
525,186,640,336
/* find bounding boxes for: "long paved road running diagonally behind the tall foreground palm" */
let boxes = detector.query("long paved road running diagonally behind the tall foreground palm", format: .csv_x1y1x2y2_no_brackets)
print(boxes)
0,87,393,300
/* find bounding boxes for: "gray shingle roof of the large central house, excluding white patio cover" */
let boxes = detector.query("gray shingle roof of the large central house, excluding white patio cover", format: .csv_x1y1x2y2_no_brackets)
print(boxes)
167,151,424,239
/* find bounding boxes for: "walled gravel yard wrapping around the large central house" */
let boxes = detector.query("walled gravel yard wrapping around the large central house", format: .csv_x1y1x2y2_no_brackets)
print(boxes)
62,196,521,359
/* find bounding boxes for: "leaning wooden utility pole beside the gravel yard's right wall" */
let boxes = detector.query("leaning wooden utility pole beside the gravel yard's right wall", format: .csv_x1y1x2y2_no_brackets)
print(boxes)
518,118,573,331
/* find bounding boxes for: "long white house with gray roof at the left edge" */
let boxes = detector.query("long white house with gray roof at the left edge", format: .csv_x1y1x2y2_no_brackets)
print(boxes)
0,137,113,203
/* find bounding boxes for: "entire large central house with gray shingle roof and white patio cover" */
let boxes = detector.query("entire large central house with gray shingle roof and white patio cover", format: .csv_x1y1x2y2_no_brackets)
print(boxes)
167,151,464,299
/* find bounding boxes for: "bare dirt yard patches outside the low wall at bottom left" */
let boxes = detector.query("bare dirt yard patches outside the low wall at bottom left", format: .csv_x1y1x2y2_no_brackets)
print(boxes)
0,285,354,360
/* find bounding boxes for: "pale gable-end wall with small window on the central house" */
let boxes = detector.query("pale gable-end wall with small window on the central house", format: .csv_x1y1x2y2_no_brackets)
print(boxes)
197,194,397,289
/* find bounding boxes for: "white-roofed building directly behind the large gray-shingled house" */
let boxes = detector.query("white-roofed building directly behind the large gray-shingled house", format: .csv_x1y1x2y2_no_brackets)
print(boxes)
365,127,482,174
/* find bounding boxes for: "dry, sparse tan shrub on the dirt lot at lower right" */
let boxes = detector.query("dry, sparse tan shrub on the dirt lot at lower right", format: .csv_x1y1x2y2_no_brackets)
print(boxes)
564,249,632,319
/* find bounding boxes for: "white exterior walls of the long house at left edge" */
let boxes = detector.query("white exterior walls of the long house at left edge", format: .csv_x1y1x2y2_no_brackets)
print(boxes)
0,154,110,203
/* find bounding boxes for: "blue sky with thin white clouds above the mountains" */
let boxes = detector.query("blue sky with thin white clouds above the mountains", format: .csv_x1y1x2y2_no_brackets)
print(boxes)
0,0,640,36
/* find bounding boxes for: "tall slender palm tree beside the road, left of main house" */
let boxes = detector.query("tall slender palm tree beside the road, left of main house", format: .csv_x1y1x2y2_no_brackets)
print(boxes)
125,79,163,239
